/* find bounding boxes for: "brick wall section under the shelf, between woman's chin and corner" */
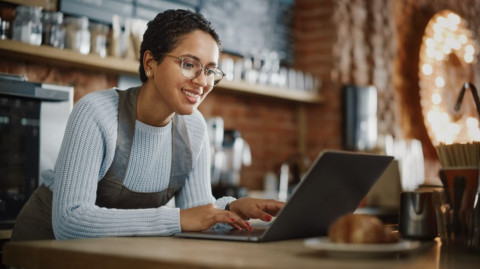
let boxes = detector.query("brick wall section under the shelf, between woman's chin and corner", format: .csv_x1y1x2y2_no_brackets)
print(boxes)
199,89,297,189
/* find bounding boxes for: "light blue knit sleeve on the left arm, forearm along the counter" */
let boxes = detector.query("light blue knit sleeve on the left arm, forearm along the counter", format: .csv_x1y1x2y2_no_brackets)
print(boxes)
52,92,181,239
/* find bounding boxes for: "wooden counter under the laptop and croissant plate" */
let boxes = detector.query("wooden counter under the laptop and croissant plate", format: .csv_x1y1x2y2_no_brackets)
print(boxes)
3,237,480,269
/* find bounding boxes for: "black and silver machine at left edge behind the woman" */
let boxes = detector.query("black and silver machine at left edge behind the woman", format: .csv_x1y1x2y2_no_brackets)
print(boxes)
0,74,73,227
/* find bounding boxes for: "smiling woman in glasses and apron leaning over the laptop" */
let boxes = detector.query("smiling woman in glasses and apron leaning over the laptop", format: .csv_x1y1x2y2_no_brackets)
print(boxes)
12,10,283,241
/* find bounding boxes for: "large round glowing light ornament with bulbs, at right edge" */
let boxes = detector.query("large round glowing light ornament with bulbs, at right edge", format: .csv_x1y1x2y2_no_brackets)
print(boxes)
419,10,480,145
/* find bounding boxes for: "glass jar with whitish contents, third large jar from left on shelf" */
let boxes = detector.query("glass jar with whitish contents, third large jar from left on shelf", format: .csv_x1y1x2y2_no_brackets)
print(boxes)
65,17,90,54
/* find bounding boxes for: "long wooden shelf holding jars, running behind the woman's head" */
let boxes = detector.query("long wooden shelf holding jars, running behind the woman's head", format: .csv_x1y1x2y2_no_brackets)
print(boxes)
0,40,323,104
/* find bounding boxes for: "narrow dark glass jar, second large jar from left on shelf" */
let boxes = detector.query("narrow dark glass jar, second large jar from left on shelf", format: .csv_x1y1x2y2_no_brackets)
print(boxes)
42,11,65,49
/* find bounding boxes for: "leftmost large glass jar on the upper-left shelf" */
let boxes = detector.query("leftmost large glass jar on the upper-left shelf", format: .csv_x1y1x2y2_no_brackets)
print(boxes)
12,6,42,46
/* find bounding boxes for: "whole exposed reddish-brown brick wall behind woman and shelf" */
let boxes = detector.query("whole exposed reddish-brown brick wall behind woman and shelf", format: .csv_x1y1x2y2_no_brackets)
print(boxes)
7,0,480,189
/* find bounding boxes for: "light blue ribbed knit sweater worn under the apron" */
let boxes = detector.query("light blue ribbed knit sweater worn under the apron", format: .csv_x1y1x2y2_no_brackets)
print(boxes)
42,89,233,239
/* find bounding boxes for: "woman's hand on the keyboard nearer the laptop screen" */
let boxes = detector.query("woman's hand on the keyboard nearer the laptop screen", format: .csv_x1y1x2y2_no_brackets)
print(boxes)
230,198,285,222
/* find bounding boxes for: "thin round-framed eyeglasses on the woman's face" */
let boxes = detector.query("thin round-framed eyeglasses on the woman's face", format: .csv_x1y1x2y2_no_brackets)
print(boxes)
165,54,225,87
